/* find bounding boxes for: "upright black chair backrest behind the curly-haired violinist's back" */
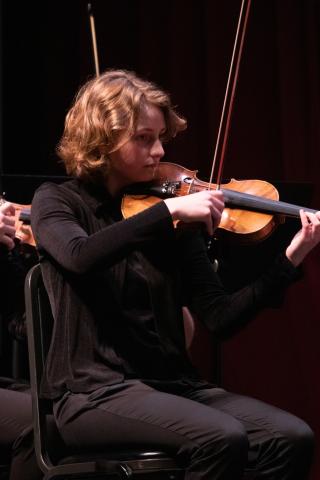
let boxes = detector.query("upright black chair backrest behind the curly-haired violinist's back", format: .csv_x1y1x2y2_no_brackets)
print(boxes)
25,264,64,471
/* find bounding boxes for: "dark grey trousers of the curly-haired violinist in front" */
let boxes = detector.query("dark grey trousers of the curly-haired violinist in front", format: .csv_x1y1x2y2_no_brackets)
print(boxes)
54,380,313,480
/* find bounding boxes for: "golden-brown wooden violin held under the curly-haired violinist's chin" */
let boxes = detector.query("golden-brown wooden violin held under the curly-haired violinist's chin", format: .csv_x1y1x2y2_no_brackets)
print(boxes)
121,162,317,244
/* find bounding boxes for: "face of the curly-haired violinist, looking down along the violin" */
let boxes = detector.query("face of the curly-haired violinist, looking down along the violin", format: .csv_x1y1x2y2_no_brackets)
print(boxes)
107,104,166,194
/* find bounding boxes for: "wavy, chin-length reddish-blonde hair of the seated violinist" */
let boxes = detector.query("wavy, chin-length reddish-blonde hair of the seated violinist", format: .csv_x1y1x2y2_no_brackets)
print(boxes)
57,70,186,179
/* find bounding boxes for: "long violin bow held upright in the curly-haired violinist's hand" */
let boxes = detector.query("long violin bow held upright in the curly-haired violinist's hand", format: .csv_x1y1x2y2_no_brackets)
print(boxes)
209,0,251,190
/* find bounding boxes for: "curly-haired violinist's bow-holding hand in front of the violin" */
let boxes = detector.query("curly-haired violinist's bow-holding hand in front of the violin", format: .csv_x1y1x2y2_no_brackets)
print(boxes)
164,190,224,235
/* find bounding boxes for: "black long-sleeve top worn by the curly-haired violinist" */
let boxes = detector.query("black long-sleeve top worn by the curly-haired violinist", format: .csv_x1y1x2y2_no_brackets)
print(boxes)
32,180,296,398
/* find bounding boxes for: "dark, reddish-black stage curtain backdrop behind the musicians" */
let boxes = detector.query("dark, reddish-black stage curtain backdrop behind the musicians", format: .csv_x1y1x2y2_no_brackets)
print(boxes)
0,0,320,480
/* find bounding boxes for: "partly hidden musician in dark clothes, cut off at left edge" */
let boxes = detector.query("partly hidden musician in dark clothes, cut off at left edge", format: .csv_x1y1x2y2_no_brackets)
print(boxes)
0,203,42,480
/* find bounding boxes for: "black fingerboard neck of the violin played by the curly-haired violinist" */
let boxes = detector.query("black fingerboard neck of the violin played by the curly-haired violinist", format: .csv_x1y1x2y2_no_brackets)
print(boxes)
221,188,317,218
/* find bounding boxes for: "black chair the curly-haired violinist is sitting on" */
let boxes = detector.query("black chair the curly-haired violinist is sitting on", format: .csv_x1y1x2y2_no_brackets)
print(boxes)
25,264,184,480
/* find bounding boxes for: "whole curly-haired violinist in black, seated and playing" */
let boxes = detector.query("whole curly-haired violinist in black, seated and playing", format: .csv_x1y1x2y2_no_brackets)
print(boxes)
32,71,320,480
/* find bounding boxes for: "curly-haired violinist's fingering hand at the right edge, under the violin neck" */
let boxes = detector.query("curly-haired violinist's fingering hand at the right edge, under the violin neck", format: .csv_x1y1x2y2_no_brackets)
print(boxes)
286,210,320,266
